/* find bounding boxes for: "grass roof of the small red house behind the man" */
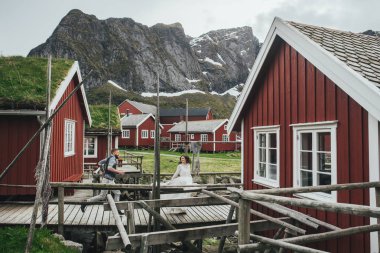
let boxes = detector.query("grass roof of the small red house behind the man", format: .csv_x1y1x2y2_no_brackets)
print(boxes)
86,104,120,131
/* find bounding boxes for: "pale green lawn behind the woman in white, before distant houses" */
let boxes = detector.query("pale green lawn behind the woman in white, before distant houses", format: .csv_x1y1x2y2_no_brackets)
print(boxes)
121,150,240,173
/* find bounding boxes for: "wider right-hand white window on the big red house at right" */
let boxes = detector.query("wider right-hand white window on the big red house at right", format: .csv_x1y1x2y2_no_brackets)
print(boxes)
293,122,336,202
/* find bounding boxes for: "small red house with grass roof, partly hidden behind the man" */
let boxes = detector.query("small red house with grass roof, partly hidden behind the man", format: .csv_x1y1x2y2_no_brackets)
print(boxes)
83,105,121,163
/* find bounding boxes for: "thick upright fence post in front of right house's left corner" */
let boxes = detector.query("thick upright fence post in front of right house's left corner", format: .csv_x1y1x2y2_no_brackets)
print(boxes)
238,199,251,245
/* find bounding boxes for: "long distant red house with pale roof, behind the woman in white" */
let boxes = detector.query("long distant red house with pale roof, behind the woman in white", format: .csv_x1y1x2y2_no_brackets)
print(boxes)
168,119,240,152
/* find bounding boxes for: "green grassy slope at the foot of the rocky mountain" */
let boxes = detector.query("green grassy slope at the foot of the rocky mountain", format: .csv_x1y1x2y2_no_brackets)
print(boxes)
87,84,236,118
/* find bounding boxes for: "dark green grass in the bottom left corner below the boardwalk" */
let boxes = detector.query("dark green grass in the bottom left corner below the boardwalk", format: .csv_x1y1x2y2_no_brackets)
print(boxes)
0,227,77,253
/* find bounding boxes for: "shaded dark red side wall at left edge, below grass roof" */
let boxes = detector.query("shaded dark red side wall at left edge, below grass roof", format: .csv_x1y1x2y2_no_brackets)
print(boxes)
0,116,40,196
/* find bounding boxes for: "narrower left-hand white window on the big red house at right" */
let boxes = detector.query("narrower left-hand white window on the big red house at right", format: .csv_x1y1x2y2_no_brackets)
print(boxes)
253,126,280,187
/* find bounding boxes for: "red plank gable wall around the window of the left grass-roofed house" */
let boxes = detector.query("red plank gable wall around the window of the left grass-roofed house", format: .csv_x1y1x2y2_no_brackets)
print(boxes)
50,76,85,182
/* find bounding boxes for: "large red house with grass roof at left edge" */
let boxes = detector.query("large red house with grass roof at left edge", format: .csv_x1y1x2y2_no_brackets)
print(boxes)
0,57,91,196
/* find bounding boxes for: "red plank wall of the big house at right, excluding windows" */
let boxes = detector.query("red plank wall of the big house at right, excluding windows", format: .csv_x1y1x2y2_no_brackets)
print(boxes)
244,42,369,252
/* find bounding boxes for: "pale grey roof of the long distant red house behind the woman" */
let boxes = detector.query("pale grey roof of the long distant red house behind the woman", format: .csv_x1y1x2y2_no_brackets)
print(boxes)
168,119,228,133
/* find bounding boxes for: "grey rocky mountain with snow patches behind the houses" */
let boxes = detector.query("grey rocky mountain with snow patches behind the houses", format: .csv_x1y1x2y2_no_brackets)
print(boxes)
29,10,259,92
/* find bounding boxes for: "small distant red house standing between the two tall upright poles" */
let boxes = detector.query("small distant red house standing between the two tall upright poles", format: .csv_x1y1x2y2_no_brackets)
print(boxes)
119,114,162,148
